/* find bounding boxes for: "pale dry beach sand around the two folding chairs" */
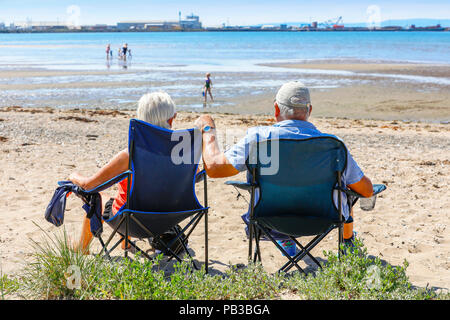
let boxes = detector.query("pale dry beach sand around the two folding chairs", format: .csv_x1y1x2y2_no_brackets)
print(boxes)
0,106,450,288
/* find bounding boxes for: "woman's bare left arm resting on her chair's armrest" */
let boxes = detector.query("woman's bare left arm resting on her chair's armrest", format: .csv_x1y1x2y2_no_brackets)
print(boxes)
69,149,129,190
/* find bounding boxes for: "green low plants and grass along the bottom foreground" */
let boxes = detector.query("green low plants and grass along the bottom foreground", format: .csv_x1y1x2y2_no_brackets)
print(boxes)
0,232,450,300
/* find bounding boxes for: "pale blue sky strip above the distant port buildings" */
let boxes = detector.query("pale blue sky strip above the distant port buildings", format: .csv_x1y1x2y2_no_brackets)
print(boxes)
0,0,450,26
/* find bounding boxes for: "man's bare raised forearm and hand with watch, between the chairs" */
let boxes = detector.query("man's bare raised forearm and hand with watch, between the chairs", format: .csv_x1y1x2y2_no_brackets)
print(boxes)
195,115,239,178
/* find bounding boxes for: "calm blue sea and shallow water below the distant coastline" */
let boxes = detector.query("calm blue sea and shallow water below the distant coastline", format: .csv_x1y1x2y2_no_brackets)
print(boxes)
0,32,450,107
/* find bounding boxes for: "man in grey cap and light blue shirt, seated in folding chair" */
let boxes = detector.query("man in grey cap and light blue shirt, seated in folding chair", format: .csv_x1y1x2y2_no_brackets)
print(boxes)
196,81,373,244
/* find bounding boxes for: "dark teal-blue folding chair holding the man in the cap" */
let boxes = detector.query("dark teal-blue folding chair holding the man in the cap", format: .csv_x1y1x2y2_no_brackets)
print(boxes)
226,135,386,272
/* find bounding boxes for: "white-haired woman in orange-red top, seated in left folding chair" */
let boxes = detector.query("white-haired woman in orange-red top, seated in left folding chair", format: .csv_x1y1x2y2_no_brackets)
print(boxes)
69,92,176,253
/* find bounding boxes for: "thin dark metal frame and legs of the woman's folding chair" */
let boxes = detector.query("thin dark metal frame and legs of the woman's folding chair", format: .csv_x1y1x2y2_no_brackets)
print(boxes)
97,126,208,273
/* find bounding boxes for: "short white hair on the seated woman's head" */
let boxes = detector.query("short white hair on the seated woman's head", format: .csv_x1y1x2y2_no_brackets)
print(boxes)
137,91,175,129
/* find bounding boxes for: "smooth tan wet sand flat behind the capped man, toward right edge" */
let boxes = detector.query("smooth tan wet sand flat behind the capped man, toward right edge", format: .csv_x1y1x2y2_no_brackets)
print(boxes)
214,60,450,123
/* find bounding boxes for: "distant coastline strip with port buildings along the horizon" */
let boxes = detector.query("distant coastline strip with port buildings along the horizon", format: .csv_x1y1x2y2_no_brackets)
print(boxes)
0,12,450,33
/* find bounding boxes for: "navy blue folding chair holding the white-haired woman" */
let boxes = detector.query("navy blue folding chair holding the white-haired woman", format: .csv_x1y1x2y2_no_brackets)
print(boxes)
78,119,209,272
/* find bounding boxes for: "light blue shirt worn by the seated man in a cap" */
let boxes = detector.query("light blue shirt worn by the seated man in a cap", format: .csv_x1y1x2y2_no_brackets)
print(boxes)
225,120,364,219
